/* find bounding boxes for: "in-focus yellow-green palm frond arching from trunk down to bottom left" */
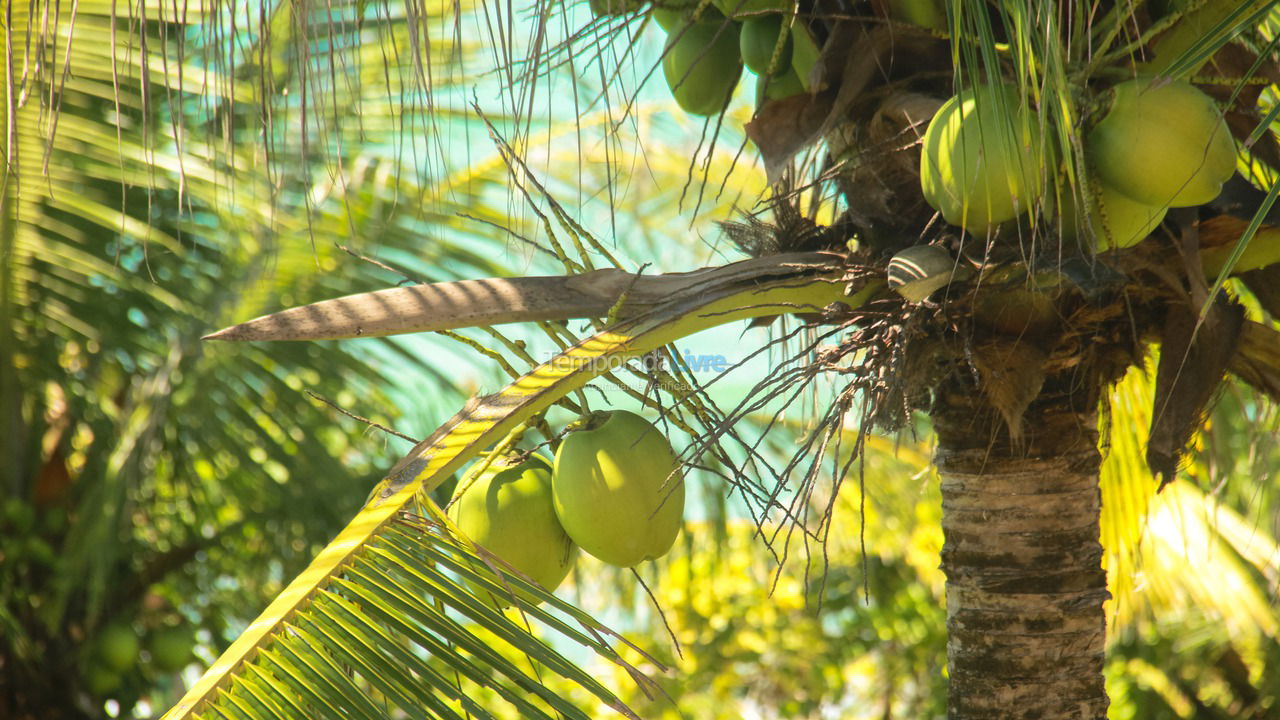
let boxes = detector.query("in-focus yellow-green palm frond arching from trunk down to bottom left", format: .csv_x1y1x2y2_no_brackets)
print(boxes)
168,254,844,720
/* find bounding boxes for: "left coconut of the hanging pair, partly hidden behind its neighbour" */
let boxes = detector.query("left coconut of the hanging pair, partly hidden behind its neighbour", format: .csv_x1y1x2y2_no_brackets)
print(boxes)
449,455,577,607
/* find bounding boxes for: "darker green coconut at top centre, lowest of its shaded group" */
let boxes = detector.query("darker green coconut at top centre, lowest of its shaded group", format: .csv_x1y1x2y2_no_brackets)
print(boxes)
662,20,742,115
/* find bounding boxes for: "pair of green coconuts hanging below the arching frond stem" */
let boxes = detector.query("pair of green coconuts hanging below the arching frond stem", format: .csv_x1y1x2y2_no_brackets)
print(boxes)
449,410,685,607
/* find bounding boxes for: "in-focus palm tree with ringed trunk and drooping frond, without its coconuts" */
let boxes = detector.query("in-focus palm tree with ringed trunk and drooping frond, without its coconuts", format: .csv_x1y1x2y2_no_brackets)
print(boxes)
10,1,1277,717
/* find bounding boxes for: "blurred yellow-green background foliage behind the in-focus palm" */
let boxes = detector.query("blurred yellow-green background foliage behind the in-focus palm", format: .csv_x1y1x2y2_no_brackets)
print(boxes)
0,1,1280,719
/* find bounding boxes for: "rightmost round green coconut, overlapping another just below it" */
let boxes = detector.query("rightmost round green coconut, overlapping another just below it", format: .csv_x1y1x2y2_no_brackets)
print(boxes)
1084,78,1235,208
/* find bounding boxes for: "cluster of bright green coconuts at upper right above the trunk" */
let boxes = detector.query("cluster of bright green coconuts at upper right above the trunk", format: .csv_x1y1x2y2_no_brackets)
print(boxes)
920,77,1235,251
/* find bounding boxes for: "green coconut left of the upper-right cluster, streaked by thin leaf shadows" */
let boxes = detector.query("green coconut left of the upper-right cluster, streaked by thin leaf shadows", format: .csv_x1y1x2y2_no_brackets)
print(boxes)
920,85,1044,232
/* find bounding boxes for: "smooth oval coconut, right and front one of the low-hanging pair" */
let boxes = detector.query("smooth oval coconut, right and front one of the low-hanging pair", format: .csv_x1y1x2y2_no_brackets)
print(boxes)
552,410,685,568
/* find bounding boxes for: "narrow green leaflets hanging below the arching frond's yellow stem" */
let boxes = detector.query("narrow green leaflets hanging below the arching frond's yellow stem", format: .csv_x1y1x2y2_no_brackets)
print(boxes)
185,501,641,717
